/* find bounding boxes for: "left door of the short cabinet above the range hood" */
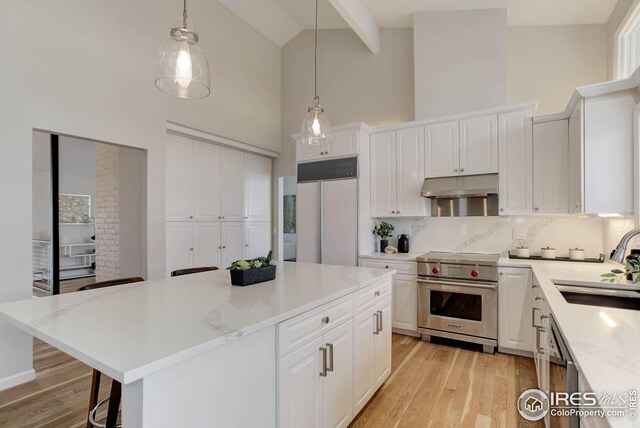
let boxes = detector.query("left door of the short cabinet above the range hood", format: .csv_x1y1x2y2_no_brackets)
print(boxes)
425,120,460,178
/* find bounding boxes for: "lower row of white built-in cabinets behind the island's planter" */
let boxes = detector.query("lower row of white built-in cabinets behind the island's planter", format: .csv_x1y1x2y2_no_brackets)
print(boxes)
166,221,271,275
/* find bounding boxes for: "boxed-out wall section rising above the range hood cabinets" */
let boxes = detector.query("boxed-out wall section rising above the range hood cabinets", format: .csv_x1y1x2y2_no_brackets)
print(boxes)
413,9,507,119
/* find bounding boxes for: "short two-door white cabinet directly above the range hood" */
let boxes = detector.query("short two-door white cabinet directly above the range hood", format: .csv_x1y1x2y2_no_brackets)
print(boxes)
425,115,498,178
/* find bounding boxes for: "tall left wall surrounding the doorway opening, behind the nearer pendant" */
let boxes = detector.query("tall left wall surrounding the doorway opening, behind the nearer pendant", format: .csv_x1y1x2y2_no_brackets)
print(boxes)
0,0,281,388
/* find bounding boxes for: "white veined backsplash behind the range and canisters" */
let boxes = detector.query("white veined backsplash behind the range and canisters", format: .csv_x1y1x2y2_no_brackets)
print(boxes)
376,217,608,257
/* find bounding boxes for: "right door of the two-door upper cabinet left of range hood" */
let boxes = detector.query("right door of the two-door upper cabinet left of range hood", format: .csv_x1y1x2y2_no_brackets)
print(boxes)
396,126,426,217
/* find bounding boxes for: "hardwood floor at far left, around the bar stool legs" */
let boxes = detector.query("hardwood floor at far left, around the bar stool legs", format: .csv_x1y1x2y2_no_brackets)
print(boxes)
0,339,111,428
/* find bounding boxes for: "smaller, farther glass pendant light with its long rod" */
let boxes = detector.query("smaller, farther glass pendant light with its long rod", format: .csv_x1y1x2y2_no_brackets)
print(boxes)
301,0,333,145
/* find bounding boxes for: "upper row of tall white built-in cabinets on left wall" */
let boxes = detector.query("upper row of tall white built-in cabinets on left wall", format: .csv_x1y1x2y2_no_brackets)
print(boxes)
166,135,271,221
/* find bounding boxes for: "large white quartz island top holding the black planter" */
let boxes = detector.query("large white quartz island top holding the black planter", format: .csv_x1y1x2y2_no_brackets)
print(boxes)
0,262,395,384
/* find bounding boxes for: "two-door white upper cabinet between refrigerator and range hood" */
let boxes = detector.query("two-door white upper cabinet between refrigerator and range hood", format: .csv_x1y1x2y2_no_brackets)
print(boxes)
371,127,426,217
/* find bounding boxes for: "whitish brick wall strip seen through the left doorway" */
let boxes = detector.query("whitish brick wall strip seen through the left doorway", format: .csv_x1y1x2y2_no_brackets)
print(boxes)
94,144,120,281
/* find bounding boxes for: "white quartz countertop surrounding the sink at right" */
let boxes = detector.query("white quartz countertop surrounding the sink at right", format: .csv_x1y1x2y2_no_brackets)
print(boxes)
499,257,640,427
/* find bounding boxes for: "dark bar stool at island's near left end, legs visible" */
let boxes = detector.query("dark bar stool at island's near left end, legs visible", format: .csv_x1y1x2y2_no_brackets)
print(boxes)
78,276,144,428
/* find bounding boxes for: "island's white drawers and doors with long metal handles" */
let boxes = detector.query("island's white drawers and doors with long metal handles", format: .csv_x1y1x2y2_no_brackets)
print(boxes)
277,280,392,428
